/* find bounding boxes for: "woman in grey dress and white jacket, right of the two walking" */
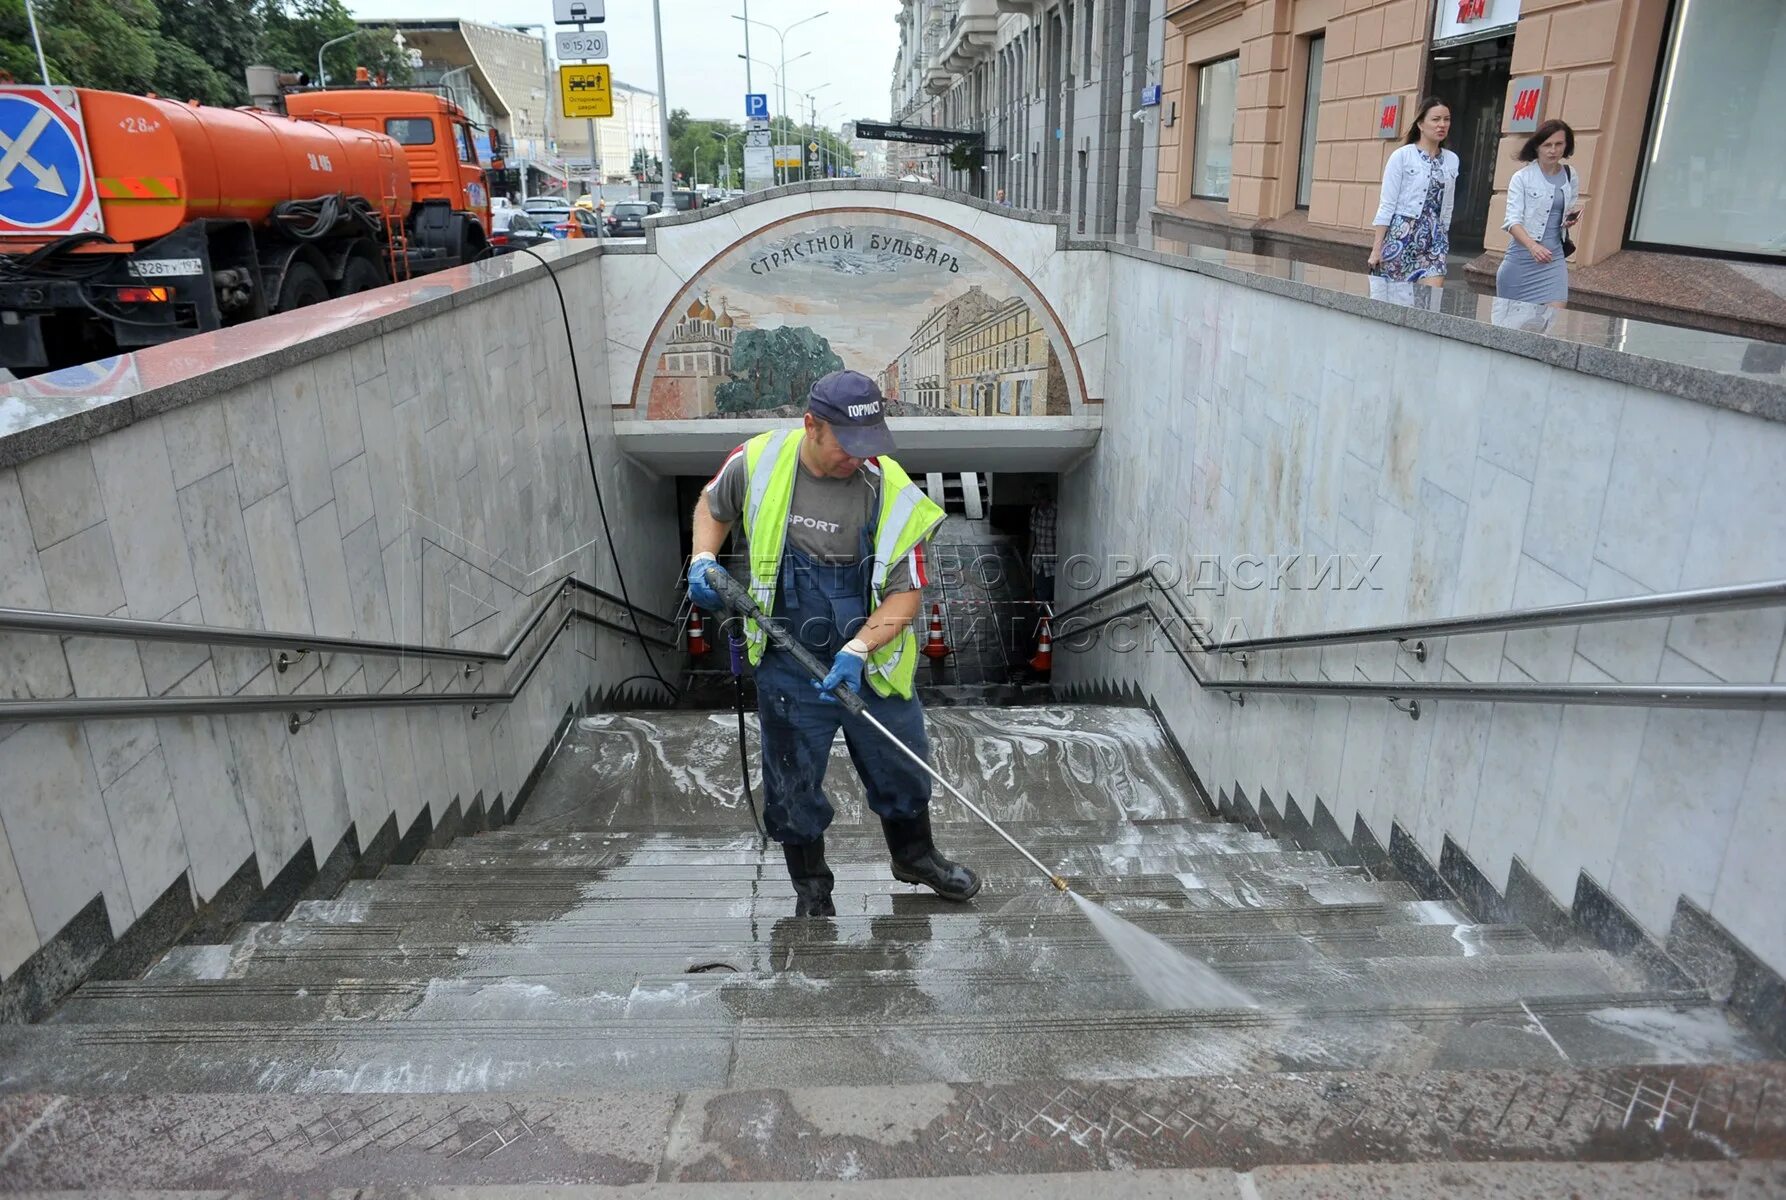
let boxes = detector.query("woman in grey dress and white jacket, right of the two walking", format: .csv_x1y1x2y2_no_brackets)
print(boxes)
1495,121,1581,309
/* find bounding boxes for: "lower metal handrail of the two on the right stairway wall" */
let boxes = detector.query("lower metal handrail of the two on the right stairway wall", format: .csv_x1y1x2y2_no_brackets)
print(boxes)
1054,580,1786,721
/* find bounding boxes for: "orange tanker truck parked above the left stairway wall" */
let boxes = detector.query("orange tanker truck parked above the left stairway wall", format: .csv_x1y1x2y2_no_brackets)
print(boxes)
0,73,500,375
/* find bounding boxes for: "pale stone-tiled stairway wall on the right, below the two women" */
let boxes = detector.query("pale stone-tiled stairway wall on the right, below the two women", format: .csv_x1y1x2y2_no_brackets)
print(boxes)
1056,255,1786,970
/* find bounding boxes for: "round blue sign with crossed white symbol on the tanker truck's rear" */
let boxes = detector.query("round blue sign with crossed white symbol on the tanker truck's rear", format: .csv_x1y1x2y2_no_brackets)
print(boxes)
0,88,104,238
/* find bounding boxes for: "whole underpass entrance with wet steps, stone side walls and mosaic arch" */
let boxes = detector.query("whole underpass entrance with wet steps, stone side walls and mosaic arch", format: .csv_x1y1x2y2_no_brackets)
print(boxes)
0,183,1786,1196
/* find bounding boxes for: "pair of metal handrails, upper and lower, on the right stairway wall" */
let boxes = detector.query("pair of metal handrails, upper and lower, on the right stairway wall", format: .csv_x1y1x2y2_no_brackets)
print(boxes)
1054,564,1786,720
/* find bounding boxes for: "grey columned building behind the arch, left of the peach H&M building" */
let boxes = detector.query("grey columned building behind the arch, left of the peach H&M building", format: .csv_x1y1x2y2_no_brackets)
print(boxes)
888,0,1164,236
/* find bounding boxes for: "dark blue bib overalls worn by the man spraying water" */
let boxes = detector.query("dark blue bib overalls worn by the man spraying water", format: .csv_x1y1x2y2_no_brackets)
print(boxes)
757,532,931,846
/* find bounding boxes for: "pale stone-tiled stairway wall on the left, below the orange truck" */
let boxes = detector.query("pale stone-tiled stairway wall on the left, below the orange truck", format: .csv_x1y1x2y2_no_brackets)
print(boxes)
0,254,677,975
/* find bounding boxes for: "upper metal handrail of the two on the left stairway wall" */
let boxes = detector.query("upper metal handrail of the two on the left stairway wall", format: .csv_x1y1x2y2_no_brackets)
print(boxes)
0,575,675,663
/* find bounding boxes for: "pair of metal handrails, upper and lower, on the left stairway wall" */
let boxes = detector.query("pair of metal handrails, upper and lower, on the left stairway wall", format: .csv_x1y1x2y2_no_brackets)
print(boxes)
0,575,677,732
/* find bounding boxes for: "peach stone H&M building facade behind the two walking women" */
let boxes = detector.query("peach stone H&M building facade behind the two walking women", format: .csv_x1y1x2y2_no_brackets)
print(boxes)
1157,0,1786,270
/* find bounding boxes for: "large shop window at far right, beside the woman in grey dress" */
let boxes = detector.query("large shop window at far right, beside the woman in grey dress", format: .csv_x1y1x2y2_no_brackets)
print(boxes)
1635,0,1786,259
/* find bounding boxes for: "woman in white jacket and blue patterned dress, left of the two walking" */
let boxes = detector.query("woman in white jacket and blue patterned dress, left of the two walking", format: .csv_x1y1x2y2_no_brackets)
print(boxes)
1368,96,1457,295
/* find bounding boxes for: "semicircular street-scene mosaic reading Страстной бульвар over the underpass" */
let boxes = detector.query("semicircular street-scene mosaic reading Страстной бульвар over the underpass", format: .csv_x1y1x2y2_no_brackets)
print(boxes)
632,209,1084,421
